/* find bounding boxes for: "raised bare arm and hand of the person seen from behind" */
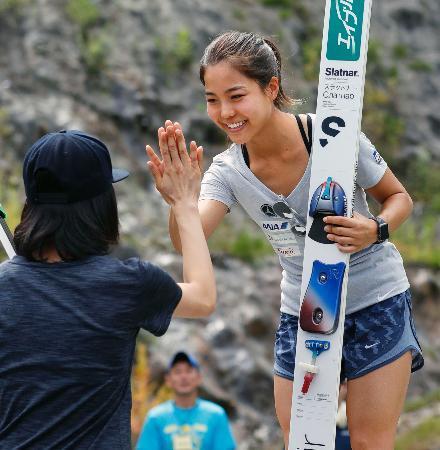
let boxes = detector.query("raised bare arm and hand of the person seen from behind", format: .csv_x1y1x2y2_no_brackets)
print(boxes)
147,122,226,318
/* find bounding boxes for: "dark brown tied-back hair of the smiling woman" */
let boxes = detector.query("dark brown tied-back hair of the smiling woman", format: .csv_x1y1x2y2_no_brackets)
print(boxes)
200,31,294,109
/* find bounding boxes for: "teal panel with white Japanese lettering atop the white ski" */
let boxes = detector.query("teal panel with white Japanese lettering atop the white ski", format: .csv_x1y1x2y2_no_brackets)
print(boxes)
327,0,364,61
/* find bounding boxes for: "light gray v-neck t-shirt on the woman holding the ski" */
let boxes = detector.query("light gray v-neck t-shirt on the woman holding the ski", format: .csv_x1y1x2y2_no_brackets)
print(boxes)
200,128,409,316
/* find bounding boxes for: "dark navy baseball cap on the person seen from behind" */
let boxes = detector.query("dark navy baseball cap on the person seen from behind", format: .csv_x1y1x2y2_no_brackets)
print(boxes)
23,130,129,204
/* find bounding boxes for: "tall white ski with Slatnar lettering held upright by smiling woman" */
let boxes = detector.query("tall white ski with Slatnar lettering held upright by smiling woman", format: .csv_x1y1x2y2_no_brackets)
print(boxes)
289,0,372,450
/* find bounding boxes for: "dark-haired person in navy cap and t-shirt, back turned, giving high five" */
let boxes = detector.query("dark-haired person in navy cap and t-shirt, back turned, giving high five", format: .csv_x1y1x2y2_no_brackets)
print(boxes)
0,131,216,450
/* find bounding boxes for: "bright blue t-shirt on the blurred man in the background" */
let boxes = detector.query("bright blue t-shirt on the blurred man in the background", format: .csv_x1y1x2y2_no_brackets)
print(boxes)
136,399,235,450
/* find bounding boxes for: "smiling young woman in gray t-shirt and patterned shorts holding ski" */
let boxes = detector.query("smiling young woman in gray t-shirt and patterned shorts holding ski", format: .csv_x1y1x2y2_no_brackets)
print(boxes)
147,31,423,450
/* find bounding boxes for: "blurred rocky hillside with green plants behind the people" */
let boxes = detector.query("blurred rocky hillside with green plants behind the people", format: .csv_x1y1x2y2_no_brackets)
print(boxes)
0,0,440,450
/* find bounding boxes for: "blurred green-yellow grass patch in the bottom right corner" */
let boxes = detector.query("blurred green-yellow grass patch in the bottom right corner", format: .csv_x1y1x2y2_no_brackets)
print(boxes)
395,416,440,450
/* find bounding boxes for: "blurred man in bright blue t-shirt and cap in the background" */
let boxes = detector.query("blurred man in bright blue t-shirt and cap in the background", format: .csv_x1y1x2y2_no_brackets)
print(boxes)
136,351,236,450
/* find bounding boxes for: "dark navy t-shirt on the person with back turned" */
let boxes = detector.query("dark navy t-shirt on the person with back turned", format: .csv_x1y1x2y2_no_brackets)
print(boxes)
0,256,182,450
